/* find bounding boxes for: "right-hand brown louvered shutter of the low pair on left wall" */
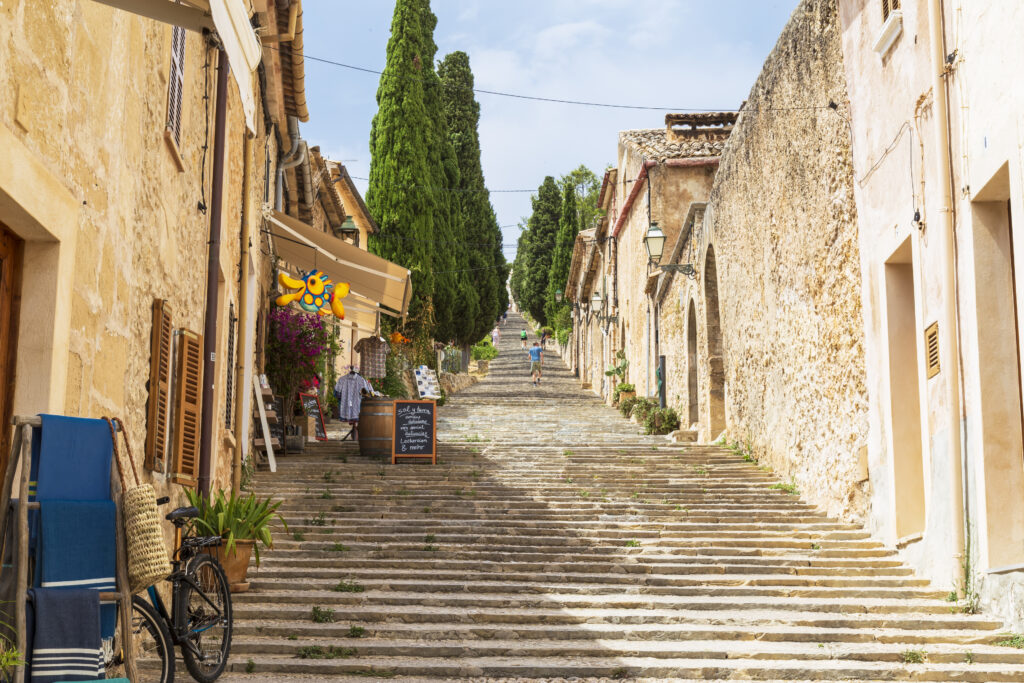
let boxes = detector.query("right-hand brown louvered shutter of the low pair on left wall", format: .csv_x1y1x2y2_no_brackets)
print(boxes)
171,330,203,486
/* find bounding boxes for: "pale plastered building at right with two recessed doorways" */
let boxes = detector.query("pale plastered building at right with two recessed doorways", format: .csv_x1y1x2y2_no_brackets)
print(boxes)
838,0,1024,629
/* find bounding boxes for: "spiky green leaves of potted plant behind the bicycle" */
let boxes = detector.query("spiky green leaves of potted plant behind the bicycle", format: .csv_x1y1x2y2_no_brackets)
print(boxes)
185,488,288,565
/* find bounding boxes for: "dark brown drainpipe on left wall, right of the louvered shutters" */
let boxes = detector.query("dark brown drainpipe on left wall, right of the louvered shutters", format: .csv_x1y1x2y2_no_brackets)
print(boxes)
199,49,228,496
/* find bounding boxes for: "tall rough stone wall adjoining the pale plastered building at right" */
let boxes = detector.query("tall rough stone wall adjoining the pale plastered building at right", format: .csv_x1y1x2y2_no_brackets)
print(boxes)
688,0,868,519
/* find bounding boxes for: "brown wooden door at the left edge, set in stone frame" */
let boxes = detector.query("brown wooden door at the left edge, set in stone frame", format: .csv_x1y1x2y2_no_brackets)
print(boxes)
0,223,25,477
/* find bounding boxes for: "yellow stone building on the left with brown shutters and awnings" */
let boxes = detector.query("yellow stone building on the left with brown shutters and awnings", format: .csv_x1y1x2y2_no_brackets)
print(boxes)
0,0,409,507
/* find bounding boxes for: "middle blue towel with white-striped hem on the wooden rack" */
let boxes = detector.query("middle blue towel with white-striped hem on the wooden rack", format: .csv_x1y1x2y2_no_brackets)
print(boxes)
36,501,117,638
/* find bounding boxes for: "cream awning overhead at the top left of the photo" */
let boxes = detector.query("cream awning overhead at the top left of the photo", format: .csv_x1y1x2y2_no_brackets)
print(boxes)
90,0,263,134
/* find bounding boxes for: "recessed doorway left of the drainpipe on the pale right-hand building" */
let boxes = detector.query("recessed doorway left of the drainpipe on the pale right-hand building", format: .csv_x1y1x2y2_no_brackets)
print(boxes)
885,238,925,539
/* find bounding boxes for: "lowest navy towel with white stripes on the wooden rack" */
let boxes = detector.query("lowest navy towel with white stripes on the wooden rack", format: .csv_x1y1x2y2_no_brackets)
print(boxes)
28,588,104,683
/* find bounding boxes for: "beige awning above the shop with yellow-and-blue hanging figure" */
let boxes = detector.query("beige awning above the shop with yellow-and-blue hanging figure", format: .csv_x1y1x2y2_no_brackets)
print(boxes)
264,209,413,321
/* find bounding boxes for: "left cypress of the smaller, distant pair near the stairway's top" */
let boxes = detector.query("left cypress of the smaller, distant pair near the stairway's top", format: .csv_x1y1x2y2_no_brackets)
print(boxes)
520,175,562,325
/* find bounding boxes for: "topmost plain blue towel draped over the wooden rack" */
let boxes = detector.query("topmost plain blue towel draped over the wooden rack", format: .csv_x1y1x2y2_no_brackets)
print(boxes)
29,415,114,501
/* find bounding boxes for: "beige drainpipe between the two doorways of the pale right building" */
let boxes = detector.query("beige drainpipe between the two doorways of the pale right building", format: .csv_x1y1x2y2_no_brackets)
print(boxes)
928,0,969,596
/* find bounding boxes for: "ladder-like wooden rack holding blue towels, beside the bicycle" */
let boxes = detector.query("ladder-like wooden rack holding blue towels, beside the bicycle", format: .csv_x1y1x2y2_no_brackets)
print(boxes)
0,416,137,683
